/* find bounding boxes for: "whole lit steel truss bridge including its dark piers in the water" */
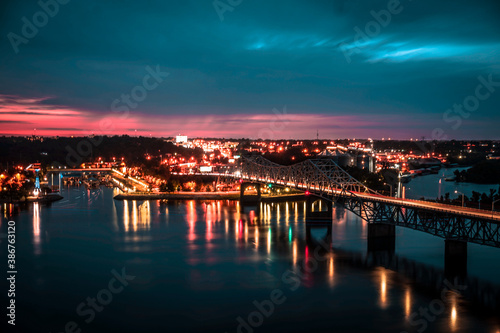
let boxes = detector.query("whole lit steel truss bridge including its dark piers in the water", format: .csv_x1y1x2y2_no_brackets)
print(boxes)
235,156,500,273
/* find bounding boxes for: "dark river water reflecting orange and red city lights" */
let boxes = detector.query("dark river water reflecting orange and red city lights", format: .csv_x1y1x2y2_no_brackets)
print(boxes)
0,175,500,333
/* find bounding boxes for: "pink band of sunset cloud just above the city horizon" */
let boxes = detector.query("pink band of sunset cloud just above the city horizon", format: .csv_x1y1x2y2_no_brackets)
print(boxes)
0,95,423,139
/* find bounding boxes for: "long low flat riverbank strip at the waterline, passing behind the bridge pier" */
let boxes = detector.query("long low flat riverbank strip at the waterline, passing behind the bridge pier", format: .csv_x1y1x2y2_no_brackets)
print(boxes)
113,191,305,202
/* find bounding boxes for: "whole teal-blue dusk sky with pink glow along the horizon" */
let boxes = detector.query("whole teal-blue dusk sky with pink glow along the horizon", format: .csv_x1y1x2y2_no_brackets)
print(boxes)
0,0,500,139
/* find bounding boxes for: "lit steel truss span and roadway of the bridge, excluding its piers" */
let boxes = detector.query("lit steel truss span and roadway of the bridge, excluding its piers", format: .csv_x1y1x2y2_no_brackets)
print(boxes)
238,156,500,247
